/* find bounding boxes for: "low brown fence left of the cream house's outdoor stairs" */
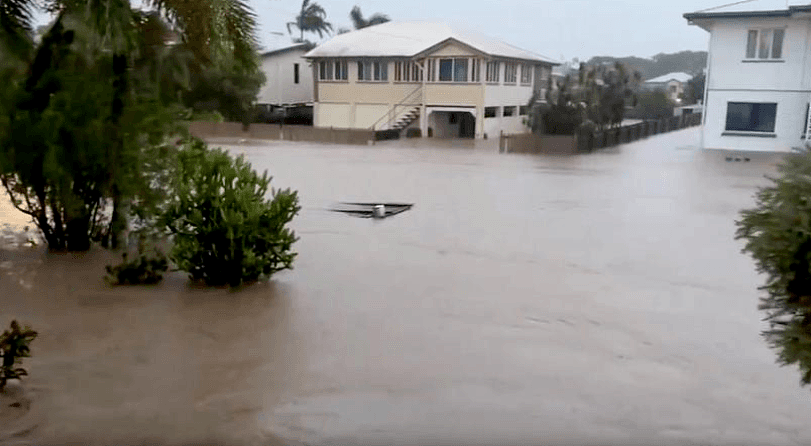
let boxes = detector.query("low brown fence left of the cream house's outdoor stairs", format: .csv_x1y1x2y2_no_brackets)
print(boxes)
189,122,375,145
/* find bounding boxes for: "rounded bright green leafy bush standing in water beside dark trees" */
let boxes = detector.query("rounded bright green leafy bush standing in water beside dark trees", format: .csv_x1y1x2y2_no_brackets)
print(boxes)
165,139,300,286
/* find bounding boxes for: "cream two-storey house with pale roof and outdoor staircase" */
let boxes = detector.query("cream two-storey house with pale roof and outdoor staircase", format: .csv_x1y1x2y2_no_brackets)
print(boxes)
306,22,558,138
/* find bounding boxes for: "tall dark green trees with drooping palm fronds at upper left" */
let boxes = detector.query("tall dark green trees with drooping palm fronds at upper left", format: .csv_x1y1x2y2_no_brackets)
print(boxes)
0,0,263,251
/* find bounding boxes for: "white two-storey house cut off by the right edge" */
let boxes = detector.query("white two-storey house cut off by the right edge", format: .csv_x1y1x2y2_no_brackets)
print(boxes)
684,0,811,152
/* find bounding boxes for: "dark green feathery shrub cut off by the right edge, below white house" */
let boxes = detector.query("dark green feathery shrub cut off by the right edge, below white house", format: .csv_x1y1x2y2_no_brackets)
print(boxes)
736,152,811,385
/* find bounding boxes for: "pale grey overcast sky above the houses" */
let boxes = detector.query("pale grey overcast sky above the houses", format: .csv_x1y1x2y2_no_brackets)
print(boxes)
255,0,731,60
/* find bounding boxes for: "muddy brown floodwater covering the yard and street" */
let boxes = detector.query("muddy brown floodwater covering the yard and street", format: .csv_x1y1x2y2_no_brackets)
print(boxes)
0,129,811,445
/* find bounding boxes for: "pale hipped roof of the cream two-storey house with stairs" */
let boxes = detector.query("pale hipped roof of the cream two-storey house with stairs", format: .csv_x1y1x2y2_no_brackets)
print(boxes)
305,22,560,65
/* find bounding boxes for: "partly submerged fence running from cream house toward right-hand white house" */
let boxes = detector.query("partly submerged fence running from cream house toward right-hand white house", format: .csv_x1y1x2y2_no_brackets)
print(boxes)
499,113,701,155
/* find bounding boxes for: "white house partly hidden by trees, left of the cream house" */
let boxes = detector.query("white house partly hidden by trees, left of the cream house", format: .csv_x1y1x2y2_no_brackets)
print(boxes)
256,43,313,120
